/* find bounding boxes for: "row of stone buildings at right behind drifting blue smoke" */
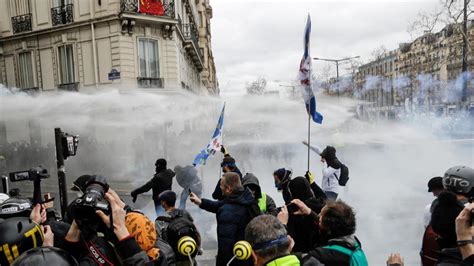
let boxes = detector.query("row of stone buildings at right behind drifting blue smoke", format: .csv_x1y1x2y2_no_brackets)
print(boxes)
353,20,474,110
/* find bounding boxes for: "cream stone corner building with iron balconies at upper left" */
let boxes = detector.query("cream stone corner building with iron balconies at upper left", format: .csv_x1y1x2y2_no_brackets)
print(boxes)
0,0,219,94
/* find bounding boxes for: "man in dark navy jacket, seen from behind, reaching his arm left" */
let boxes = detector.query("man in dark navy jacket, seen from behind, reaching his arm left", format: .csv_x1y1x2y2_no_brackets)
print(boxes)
190,172,260,265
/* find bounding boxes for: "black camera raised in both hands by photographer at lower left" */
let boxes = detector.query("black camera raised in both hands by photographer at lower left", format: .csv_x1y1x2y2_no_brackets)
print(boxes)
68,175,110,232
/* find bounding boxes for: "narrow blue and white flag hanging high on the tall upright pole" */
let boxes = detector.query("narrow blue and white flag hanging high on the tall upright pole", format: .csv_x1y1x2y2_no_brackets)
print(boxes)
299,14,323,124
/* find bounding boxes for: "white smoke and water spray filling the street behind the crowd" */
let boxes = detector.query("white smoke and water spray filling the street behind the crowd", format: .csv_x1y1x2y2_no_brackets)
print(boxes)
0,83,474,265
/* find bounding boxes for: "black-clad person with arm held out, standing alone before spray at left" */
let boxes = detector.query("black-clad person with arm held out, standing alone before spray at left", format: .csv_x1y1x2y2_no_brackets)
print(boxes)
130,159,175,216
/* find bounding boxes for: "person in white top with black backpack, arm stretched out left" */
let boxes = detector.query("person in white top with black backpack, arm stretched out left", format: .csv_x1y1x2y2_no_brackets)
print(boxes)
303,141,343,201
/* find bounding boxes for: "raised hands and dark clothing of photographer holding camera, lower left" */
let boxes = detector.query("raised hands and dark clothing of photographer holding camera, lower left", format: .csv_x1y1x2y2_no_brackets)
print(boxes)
66,185,149,265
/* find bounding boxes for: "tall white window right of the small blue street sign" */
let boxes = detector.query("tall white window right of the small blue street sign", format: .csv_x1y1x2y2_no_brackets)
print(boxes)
138,39,160,78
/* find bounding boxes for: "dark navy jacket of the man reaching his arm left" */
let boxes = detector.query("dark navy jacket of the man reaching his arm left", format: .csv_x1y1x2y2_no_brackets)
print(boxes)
199,189,258,265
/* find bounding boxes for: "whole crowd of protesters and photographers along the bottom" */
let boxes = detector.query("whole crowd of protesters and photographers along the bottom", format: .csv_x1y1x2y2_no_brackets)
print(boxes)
0,142,474,266
